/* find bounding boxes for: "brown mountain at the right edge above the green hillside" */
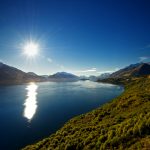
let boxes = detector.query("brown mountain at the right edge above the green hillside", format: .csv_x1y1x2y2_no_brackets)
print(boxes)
110,63,150,78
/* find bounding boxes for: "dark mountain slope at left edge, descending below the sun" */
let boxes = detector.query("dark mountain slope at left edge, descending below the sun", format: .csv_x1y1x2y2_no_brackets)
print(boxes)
0,63,44,84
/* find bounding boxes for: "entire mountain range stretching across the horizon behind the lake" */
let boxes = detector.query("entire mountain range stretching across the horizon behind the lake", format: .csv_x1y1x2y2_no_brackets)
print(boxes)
0,63,150,84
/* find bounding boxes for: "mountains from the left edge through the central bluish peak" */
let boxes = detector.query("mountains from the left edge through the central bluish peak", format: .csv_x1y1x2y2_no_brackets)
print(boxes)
0,62,79,84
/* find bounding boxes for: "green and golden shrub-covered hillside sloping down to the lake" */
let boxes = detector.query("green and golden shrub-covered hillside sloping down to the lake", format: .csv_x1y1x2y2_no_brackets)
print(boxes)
24,77,150,150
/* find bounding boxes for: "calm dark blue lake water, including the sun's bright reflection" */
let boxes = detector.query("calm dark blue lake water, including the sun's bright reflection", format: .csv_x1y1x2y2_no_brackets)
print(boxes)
0,81,123,150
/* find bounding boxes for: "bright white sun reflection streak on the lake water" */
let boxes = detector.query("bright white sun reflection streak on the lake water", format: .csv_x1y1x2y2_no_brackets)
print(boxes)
23,83,38,121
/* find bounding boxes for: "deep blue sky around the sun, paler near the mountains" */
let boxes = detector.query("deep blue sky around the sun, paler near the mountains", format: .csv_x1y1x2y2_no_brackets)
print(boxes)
0,0,150,75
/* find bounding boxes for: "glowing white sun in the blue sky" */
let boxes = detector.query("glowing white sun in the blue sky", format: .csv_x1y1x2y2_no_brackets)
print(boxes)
23,42,39,57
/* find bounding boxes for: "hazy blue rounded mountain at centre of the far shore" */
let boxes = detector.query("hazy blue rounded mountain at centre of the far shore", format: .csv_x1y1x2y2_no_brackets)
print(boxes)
49,72,79,81
